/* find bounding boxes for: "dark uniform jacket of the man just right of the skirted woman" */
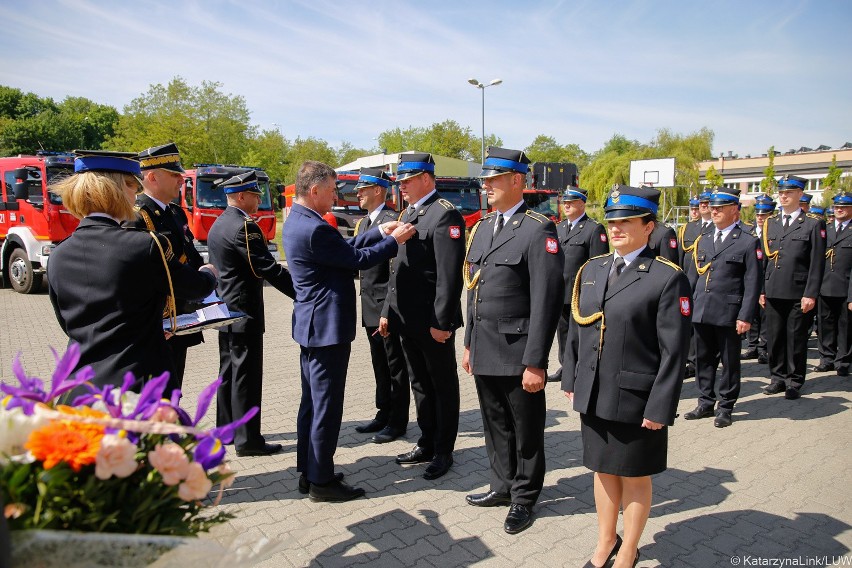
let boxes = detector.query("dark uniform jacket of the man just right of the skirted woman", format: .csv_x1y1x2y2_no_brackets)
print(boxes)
692,225,763,327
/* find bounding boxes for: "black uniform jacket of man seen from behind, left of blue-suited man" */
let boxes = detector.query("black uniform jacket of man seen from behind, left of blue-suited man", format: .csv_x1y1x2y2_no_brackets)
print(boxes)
207,206,295,333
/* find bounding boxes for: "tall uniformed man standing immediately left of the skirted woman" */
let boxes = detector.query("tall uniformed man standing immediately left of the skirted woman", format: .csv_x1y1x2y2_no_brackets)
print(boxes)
462,146,564,534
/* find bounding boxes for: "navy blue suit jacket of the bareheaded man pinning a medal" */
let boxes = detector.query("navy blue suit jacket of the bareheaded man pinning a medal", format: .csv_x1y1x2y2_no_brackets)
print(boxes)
281,203,398,347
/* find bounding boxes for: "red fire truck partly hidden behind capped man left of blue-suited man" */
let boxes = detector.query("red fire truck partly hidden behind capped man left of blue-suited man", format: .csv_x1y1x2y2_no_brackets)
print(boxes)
178,164,280,261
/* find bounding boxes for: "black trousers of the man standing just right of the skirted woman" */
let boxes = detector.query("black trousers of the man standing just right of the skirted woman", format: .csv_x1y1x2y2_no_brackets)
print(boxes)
692,323,741,410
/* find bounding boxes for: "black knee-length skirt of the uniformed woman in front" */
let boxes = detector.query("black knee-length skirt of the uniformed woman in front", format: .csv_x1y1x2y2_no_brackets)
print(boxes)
580,414,669,477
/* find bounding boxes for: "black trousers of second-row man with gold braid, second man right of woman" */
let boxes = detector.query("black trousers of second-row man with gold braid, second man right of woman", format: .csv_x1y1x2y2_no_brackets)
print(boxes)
766,298,812,389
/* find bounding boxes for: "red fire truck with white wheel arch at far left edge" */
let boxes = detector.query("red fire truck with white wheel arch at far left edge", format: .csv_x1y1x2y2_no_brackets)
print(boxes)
0,152,79,294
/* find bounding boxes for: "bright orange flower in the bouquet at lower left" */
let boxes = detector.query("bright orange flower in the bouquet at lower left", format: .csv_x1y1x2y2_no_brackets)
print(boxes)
24,406,105,471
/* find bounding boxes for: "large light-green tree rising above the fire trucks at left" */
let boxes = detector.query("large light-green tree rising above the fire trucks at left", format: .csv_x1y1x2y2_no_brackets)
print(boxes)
108,77,256,164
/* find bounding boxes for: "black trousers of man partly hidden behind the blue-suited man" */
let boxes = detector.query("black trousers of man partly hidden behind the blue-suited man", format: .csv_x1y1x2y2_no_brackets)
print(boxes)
364,326,411,430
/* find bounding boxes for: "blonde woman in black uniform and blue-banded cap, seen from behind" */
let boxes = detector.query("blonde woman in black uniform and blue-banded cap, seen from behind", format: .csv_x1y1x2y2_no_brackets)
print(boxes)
47,150,216,391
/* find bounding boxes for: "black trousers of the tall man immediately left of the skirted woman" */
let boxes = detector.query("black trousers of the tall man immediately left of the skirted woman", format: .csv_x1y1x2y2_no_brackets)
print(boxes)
474,375,547,506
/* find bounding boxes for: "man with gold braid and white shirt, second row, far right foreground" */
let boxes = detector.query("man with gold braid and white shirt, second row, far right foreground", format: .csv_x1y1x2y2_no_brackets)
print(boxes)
760,175,825,400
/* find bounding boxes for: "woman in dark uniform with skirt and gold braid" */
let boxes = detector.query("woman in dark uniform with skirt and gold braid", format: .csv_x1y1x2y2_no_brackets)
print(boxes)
562,186,692,568
